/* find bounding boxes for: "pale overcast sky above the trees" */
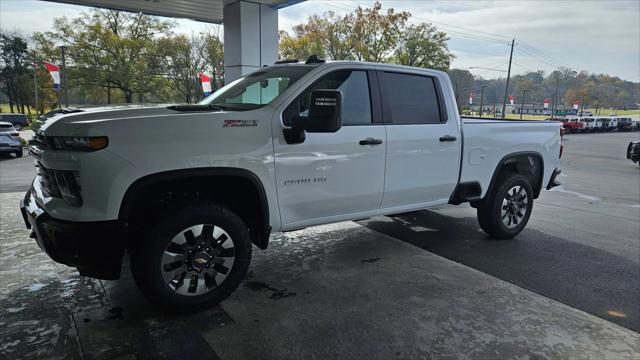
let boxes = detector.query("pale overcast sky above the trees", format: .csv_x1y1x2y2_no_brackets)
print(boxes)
0,0,640,82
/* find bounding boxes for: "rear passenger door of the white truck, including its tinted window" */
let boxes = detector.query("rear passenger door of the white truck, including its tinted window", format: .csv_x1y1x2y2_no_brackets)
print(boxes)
378,71,461,208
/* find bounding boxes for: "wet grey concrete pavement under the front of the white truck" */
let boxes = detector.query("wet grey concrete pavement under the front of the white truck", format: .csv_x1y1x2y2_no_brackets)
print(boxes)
0,193,640,359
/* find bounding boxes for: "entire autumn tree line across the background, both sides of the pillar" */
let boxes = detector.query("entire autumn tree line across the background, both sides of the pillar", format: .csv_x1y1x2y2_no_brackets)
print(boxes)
0,3,640,113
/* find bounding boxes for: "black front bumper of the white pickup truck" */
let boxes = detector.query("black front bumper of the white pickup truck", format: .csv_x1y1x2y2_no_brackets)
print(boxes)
20,189,126,280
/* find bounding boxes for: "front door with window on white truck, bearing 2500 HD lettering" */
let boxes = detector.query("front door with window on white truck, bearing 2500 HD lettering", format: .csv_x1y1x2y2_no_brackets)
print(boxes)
274,70,386,230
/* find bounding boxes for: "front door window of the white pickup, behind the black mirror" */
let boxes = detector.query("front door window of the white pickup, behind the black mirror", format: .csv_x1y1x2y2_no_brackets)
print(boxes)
285,70,371,125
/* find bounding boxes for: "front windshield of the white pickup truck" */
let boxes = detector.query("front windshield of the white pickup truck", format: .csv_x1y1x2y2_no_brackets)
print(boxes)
199,65,315,111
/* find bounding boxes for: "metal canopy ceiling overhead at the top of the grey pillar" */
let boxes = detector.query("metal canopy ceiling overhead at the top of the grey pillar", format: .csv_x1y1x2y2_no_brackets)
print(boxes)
45,0,304,24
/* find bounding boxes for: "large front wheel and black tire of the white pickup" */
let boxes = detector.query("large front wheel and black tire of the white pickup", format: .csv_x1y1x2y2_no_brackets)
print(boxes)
131,203,251,312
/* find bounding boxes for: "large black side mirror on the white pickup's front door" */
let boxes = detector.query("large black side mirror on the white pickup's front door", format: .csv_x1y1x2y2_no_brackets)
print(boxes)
291,90,342,133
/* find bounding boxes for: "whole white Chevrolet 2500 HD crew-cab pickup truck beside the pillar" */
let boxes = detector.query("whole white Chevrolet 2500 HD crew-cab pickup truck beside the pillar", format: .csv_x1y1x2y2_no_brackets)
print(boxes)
21,61,562,311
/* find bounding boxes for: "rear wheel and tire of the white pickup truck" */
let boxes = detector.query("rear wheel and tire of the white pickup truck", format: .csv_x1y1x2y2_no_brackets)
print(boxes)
477,173,533,239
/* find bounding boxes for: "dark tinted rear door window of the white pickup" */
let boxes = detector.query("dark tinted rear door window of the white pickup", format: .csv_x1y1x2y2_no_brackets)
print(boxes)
382,72,441,124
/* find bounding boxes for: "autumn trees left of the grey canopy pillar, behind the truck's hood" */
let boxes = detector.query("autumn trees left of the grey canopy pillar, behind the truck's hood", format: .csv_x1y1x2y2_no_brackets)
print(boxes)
0,10,224,112
